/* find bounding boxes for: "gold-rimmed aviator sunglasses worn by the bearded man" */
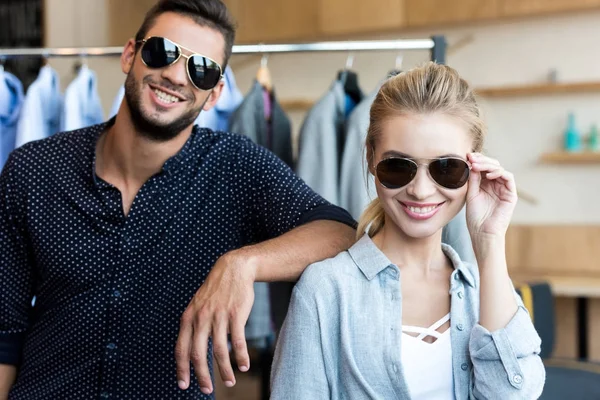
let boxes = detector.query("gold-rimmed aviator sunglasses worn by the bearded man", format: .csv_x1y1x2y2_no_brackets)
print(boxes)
136,36,223,90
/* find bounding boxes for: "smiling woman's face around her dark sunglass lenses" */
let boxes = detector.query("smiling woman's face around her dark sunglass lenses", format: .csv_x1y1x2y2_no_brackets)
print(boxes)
370,113,473,238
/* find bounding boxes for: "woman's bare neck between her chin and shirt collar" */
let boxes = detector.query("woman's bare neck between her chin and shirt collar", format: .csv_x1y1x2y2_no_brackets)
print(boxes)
373,221,448,275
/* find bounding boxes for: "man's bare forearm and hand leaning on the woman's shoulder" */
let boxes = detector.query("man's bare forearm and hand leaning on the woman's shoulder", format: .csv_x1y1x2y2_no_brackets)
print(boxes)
175,220,356,393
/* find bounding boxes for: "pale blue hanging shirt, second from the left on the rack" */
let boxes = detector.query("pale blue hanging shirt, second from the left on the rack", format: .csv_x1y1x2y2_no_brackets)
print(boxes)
15,65,63,147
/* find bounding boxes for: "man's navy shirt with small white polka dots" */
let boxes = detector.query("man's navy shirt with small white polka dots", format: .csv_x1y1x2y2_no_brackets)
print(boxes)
0,119,355,400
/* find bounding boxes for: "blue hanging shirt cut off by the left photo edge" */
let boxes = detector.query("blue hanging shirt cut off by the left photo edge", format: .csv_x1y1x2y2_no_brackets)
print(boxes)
0,71,24,171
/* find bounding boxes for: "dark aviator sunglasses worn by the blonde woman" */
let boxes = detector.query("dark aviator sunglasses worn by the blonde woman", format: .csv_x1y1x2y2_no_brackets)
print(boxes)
375,157,471,189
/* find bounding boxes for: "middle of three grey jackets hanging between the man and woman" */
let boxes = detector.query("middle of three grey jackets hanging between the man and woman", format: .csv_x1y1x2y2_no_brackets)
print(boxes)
296,81,346,205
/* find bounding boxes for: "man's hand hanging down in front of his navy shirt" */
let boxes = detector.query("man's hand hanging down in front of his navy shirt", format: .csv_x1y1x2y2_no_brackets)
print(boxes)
175,249,256,394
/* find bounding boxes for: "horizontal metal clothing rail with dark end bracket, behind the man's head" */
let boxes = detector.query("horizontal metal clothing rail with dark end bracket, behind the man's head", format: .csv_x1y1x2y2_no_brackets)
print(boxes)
0,36,447,64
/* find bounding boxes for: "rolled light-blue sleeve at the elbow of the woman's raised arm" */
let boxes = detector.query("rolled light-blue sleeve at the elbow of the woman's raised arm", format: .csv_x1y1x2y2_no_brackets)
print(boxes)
469,305,546,399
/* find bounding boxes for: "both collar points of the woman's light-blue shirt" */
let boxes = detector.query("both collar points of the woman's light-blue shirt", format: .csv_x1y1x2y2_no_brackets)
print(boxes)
348,234,476,287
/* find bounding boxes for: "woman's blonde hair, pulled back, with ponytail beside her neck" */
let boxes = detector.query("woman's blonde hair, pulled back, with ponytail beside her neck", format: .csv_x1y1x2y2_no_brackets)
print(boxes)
357,62,486,237
